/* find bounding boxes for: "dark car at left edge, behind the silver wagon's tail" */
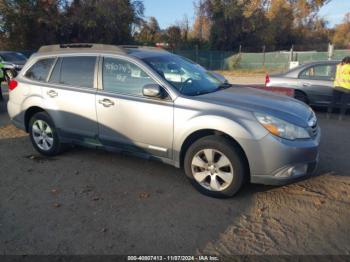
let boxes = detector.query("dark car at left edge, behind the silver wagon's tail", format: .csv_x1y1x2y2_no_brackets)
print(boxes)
0,51,27,82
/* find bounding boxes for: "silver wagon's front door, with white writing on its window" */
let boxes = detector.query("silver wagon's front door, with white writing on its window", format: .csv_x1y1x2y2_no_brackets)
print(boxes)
96,57,174,158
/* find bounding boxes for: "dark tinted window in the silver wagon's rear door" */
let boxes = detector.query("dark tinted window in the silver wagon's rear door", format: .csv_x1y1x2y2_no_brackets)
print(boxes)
50,56,96,88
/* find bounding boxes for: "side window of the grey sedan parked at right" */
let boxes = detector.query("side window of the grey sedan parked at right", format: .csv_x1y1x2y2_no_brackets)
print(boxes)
299,64,336,81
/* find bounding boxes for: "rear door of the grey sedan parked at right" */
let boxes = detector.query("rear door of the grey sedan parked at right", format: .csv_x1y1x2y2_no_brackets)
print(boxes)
298,63,336,104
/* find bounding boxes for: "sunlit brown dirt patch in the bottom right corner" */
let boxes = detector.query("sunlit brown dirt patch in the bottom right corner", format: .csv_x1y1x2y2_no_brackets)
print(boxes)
198,174,350,255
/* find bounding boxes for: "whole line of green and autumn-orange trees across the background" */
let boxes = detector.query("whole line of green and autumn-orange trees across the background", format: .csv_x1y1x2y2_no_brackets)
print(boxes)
0,0,342,52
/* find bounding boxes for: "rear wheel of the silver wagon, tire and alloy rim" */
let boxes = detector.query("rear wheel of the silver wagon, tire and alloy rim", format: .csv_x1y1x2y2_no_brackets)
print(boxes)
28,112,63,156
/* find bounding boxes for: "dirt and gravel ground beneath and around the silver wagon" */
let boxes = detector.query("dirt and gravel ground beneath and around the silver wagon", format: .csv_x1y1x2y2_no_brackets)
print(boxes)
0,84,350,255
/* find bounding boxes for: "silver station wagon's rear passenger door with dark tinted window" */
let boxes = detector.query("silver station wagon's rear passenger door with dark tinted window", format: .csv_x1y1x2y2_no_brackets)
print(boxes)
43,55,98,141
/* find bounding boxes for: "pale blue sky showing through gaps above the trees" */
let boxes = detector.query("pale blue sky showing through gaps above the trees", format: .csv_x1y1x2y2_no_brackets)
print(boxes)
143,0,350,28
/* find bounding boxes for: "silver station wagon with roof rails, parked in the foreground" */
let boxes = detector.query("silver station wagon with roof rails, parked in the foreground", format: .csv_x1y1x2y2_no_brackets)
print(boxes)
8,44,321,197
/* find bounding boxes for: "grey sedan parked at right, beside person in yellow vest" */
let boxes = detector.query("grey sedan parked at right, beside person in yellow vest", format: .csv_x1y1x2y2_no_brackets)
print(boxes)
266,61,340,106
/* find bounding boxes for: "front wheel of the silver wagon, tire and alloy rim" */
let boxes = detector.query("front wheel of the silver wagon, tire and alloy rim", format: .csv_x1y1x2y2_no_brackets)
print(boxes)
184,136,247,198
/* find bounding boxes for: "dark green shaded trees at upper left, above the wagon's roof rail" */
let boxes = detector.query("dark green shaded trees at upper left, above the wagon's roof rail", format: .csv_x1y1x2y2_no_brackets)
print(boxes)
0,0,144,49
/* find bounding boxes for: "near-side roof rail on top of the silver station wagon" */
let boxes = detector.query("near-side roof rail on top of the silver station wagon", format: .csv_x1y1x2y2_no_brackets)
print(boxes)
38,43,127,54
